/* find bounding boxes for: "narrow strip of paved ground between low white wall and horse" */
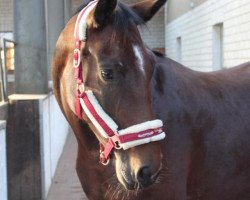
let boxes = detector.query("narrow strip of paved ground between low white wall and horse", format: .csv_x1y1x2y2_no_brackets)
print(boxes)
47,133,87,200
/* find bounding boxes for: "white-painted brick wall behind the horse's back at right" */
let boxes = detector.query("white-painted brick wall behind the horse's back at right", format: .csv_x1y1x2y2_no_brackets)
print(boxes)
166,0,250,71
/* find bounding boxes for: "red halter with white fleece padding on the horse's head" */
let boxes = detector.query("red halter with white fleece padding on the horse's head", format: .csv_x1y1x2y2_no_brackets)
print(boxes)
74,0,165,165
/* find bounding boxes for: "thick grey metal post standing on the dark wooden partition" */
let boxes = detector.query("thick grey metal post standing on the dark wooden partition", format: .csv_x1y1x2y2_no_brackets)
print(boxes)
13,0,48,94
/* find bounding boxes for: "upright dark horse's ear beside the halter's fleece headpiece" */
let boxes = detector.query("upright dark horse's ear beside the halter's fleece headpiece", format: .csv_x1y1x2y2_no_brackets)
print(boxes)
91,0,117,27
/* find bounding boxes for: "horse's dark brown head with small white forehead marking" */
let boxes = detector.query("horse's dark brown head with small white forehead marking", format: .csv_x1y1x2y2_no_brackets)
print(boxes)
56,0,165,189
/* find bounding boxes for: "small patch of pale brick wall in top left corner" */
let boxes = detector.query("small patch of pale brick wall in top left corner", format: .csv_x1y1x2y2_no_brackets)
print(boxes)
0,0,13,32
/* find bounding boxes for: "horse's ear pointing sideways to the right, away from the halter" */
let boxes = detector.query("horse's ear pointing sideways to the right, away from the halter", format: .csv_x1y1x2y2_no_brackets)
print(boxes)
131,0,167,22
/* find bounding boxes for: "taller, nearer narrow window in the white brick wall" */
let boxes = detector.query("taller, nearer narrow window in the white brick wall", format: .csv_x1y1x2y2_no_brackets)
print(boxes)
213,23,224,70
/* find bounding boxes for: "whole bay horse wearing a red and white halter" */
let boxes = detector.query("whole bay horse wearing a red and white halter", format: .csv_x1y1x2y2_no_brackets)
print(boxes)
52,0,250,200
